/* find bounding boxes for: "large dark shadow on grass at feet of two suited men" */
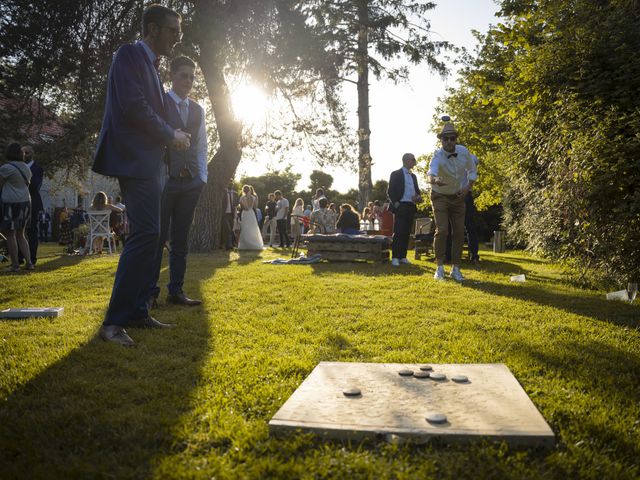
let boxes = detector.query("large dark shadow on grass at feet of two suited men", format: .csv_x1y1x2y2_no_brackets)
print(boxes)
0,256,216,478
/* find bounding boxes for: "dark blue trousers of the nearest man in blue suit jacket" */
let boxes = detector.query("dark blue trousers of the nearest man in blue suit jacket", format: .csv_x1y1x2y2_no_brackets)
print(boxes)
103,171,162,327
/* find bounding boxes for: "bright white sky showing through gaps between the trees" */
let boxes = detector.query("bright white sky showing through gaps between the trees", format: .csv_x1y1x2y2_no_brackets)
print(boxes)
236,0,499,192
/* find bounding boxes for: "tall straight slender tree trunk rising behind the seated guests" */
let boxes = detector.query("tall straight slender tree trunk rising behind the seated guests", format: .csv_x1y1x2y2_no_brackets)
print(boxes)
356,0,372,211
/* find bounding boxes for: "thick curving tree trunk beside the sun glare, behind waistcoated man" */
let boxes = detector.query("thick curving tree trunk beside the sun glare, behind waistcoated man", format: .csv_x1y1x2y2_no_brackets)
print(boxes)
189,2,242,252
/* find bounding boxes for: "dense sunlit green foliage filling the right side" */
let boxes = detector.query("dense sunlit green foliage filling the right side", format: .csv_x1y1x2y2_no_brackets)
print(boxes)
441,0,640,285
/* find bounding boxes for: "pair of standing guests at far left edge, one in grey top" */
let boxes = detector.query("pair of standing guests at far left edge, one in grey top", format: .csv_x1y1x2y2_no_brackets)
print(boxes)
0,143,44,272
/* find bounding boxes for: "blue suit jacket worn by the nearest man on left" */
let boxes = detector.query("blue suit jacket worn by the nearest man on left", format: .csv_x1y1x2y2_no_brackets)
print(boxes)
93,42,174,178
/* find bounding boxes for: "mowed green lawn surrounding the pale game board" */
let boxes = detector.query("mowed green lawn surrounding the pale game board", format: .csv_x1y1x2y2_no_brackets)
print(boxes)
0,246,640,479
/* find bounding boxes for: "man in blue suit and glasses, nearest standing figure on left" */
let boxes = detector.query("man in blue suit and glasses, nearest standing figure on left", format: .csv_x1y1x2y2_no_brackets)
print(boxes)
93,5,190,346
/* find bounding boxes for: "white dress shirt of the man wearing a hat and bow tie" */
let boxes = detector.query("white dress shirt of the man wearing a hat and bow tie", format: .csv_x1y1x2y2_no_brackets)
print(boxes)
427,145,478,195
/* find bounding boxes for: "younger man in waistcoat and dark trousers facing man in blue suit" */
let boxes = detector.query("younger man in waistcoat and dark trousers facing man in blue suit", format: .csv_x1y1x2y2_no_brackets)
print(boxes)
150,57,207,306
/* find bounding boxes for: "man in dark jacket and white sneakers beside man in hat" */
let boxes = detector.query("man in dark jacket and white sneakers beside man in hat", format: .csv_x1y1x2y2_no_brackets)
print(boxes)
387,153,422,267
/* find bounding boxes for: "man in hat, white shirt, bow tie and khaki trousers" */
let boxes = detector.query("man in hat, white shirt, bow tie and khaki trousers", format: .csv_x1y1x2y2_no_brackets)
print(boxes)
427,117,478,282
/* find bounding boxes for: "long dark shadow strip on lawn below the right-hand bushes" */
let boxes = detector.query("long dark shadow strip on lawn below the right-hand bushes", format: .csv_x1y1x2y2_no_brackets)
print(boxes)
464,276,640,327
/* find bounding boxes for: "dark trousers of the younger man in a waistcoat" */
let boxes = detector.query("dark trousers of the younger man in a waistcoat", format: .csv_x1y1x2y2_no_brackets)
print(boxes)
149,178,204,298
